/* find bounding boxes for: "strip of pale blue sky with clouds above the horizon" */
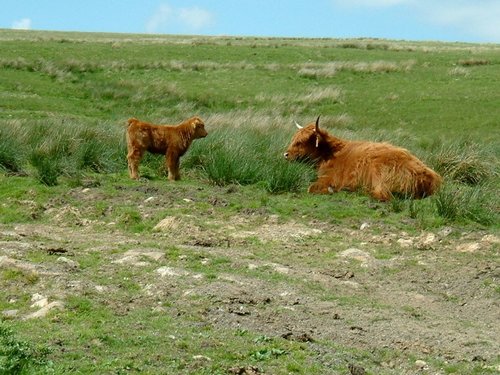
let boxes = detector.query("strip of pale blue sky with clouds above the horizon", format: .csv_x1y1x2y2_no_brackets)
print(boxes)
0,0,500,43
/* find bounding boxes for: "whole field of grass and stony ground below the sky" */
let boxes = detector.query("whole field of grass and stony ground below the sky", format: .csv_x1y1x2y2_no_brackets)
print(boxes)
0,30,500,374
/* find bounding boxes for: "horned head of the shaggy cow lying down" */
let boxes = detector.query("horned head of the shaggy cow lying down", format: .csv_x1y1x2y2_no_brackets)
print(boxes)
284,117,325,161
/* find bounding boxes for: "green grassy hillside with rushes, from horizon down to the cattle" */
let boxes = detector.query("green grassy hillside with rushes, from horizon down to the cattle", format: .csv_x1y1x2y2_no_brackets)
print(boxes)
0,31,500,222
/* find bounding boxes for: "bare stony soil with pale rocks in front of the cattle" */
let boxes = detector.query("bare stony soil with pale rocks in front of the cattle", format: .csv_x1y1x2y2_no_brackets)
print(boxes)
0,183,500,373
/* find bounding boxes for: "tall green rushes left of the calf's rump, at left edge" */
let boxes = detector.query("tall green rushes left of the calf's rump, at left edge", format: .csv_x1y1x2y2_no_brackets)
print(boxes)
0,120,125,186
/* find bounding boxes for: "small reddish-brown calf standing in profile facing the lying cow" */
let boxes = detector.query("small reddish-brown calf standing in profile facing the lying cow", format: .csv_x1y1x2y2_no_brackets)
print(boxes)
127,117,207,180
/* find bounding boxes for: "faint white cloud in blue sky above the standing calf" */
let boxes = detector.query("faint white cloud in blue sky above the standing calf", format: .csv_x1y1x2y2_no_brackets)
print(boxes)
146,4,214,33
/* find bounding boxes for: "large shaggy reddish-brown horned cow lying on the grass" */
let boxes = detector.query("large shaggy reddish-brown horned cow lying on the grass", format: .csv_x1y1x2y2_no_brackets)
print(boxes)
285,117,441,201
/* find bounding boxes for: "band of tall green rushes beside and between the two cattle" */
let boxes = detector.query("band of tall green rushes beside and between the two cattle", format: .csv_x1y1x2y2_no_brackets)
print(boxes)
0,112,499,225
